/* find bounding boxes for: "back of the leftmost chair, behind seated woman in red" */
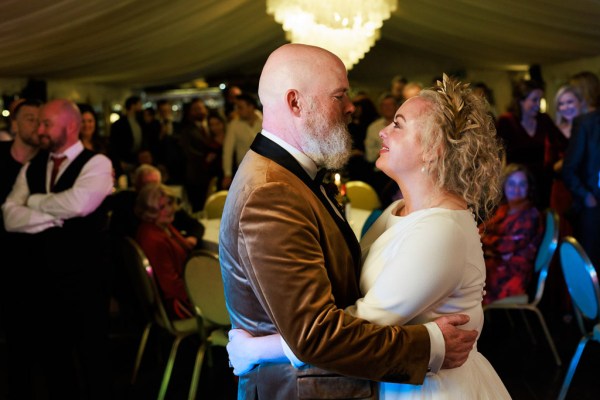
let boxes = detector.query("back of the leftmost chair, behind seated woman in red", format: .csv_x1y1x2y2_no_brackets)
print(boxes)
121,237,175,332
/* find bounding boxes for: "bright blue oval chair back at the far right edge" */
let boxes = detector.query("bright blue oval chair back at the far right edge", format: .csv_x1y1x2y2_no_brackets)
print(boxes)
560,236,600,320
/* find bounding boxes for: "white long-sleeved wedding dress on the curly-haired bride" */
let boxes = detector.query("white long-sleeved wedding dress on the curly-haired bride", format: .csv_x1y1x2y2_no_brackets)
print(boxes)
346,200,510,400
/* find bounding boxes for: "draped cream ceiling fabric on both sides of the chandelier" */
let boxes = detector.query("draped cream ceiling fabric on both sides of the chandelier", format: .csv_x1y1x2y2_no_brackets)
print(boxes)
0,0,600,90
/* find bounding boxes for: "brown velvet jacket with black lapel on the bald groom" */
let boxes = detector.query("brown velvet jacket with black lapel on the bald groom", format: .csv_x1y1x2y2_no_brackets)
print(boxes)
219,134,430,400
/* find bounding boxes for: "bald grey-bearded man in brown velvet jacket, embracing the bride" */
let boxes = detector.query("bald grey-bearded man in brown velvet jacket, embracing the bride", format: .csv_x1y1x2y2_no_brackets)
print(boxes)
219,44,476,399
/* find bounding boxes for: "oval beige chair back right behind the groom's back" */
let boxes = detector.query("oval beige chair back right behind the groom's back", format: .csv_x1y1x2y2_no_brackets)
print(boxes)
185,250,231,326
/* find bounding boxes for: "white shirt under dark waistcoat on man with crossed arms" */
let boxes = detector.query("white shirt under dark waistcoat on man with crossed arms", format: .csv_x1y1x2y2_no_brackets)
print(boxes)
2,141,113,233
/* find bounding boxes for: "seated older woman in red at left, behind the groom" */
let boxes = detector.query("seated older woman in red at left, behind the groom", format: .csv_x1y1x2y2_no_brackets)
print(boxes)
135,183,193,319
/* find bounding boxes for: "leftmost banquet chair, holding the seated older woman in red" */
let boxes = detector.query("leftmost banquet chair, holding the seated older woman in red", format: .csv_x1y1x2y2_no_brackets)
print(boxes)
122,237,198,400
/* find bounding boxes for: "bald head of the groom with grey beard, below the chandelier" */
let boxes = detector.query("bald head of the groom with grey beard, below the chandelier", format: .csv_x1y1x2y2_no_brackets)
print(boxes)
258,44,354,168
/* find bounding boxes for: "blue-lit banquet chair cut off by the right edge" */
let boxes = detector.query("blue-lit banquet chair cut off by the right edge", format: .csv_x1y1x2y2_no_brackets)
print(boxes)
558,236,600,400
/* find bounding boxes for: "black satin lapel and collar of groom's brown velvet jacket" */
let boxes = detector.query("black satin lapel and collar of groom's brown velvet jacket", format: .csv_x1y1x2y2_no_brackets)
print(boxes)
250,133,361,266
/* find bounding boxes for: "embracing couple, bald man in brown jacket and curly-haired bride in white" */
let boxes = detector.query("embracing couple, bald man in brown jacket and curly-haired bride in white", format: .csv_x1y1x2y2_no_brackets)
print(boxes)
219,44,510,400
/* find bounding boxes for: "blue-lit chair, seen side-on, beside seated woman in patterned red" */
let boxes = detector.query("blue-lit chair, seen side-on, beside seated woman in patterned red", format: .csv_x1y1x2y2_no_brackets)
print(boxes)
483,209,562,366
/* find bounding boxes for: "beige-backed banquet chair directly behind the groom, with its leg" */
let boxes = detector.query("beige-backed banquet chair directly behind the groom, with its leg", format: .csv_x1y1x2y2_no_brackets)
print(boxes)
185,250,231,400
